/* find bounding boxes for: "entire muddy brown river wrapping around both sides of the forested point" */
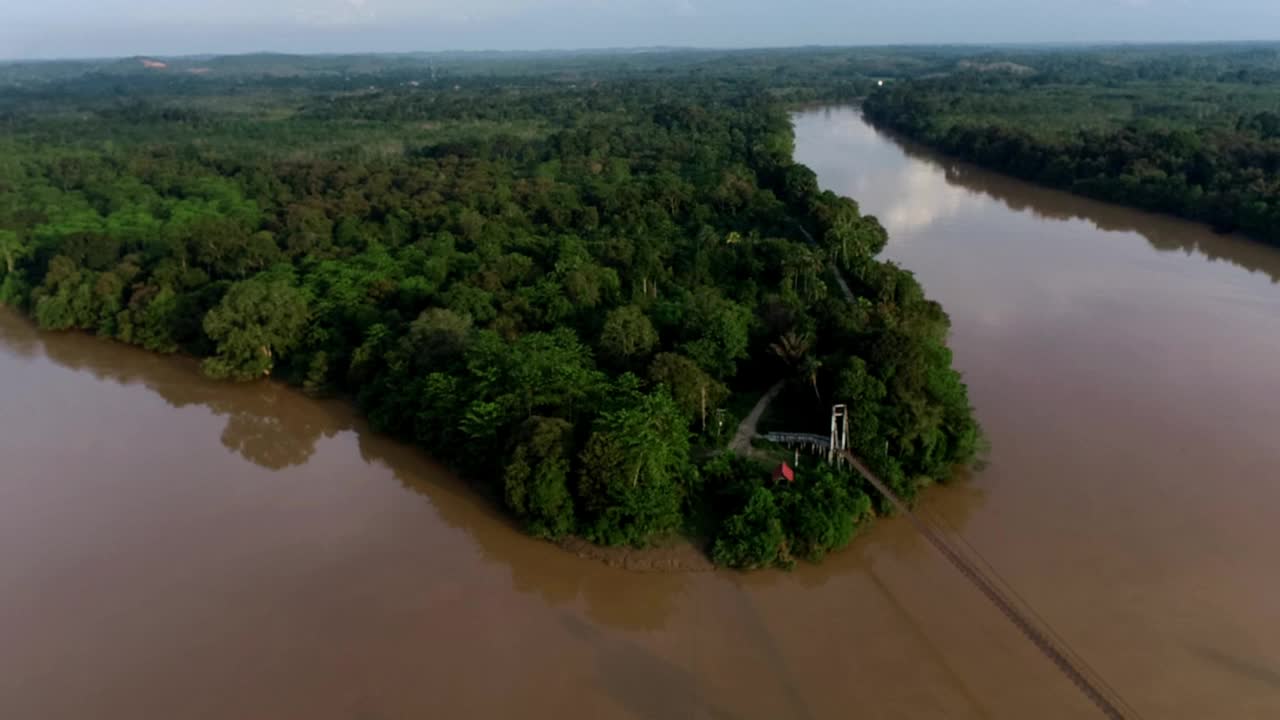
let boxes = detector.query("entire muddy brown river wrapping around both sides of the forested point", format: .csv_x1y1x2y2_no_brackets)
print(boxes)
0,109,1280,720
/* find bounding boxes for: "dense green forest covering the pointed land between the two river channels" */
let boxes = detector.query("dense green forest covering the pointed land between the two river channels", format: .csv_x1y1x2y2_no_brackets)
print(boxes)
0,50,979,568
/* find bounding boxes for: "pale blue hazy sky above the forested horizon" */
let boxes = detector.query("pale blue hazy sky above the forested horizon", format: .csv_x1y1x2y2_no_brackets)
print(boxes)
0,0,1280,58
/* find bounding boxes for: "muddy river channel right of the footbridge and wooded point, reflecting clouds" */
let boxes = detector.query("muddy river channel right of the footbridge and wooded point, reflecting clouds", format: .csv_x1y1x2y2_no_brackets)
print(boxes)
796,109,1280,717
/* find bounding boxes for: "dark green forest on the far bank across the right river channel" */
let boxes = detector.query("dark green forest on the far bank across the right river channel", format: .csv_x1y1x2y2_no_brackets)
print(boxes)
864,45,1280,243
